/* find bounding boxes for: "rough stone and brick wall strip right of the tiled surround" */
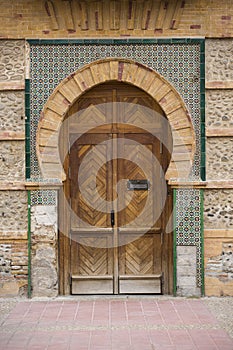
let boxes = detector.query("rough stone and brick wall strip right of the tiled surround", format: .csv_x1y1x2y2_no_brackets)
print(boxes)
204,39,233,296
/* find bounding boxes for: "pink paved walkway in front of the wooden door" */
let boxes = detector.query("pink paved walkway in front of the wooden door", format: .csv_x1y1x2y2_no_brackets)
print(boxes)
0,297,233,350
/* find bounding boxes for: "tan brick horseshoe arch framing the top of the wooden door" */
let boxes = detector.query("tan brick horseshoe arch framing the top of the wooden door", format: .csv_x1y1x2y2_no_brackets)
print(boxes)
36,58,195,181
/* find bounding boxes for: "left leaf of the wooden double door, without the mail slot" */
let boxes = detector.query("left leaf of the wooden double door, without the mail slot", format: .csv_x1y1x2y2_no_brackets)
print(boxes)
70,134,113,294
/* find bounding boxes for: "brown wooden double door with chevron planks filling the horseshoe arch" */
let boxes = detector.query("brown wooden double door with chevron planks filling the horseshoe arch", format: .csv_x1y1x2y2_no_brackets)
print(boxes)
60,83,172,294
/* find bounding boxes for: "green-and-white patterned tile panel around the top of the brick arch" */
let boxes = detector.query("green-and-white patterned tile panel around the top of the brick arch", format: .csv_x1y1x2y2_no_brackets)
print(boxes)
30,40,201,185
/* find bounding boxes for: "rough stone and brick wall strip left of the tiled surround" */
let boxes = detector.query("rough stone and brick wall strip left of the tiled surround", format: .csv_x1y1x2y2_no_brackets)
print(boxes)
0,40,28,296
